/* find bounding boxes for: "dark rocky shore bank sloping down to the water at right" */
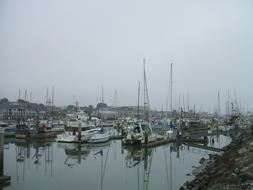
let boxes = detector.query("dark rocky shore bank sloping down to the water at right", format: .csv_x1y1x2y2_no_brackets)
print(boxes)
180,129,253,190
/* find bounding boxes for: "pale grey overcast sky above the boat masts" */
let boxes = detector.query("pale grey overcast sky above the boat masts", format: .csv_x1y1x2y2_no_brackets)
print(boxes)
0,0,253,111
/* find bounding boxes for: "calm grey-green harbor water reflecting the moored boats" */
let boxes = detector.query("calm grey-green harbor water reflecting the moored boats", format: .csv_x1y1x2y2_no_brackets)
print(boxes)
4,135,231,190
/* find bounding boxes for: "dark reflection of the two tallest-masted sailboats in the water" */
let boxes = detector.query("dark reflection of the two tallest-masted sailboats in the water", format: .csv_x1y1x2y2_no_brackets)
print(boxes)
122,143,183,190
